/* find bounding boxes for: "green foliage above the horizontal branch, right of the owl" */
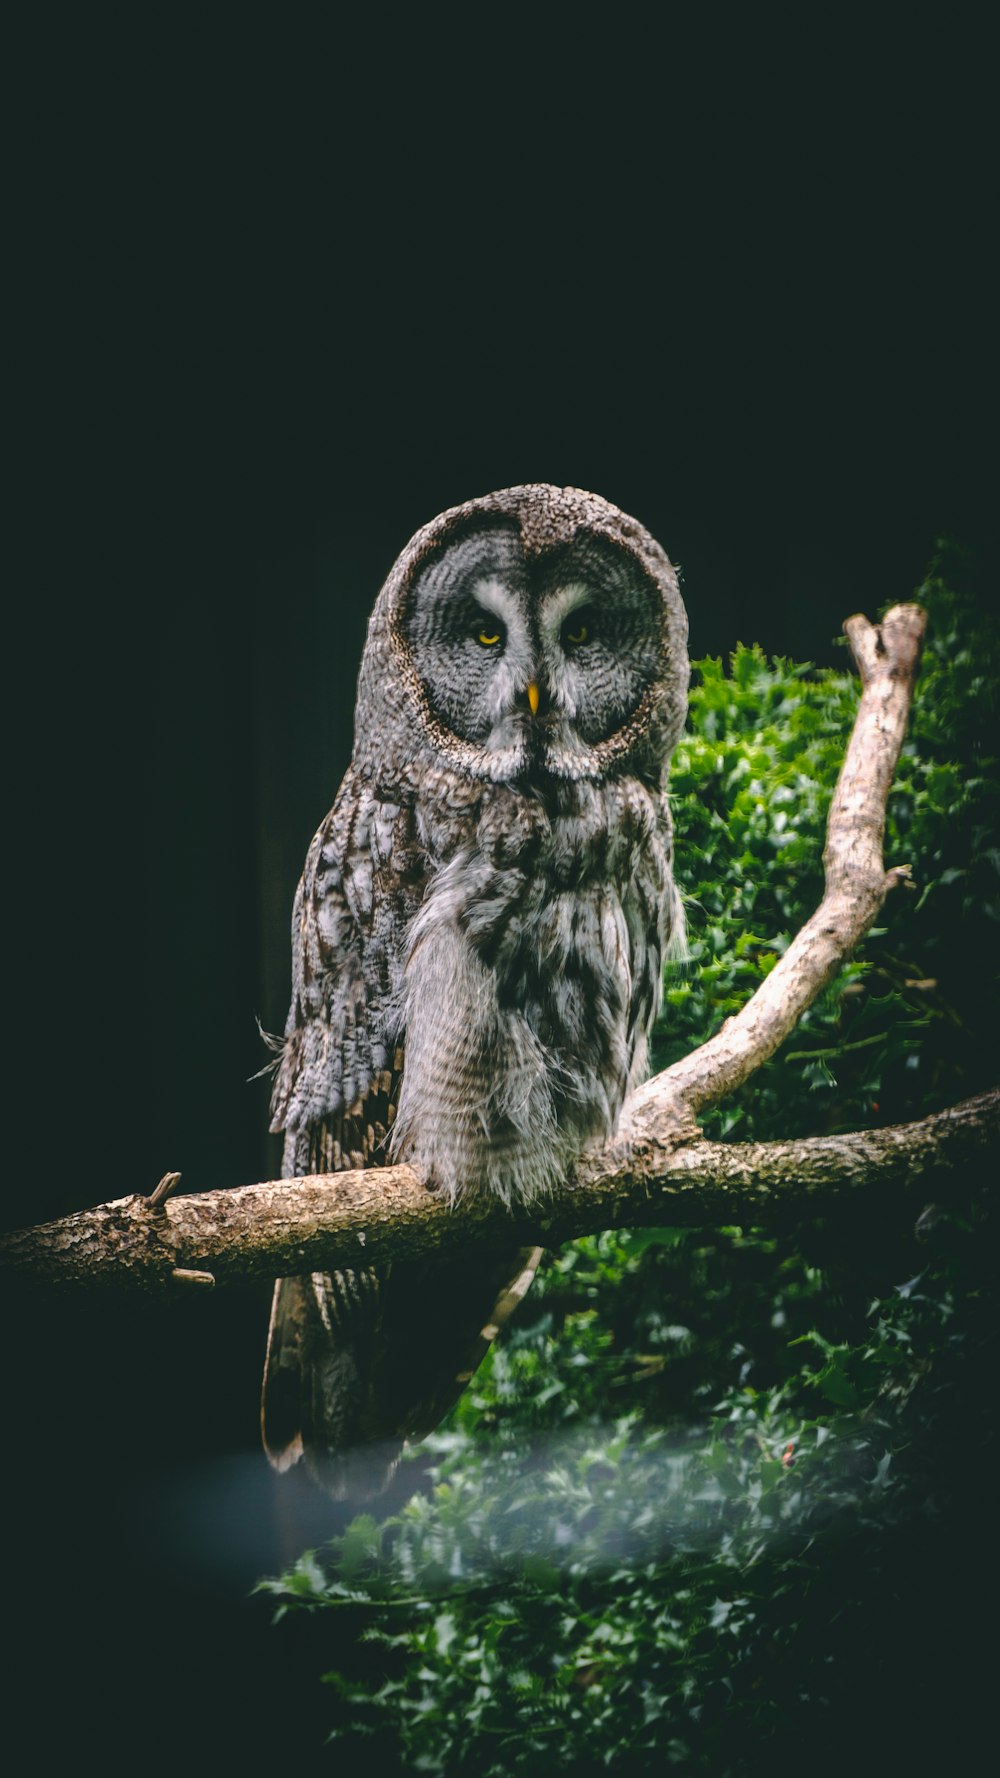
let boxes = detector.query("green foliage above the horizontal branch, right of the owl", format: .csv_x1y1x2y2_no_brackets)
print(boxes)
655,547,1000,1140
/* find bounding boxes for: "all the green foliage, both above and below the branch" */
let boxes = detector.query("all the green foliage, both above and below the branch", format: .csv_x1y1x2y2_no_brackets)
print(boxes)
263,551,1000,1778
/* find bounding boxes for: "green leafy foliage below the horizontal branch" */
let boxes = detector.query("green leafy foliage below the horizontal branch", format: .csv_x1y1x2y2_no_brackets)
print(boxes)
263,1216,986,1778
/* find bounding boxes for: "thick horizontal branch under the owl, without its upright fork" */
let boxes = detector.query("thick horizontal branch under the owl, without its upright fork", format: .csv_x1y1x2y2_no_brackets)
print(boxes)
0,1090,1000,1293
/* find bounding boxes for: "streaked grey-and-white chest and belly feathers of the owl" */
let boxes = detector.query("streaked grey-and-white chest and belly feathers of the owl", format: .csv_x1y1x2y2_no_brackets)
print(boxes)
387,779,669,1197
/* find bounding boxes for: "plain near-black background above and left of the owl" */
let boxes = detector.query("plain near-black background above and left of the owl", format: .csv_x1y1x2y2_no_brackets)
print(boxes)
5,12,996,1769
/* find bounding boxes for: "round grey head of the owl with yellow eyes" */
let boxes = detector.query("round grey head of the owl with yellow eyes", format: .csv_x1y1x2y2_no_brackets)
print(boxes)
356,484,689,784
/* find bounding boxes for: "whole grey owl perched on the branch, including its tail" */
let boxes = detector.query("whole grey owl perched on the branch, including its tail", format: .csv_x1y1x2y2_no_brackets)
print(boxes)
262,484,689,1499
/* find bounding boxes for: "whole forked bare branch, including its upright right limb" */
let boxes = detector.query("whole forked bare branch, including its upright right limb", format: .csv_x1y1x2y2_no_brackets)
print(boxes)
0,590,982,1291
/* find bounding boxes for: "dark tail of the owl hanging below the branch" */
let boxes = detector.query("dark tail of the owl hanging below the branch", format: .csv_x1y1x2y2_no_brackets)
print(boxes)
262,1246,543,1501
